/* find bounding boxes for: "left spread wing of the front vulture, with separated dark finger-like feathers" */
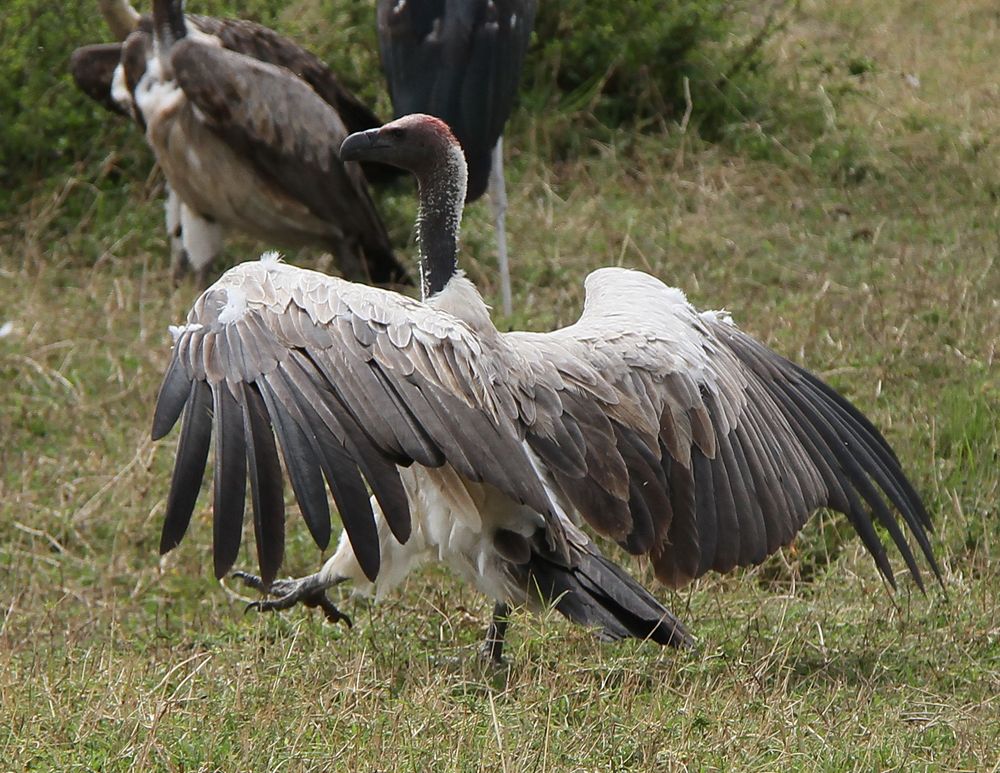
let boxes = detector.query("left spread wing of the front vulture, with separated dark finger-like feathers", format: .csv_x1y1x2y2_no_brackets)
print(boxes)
153,260,550,583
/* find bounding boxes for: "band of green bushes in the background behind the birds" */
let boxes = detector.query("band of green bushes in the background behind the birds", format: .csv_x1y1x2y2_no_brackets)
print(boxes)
0,0,822,217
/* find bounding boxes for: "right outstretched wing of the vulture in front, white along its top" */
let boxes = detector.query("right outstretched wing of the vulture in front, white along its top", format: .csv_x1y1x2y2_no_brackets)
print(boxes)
508,269,940,587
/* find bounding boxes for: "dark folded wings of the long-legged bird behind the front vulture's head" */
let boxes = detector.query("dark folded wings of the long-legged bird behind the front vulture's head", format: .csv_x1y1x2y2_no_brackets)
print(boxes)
377,0,537,201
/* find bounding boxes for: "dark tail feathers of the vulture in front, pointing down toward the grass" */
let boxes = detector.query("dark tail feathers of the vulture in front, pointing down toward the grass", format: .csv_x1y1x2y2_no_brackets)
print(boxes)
522,543,694,648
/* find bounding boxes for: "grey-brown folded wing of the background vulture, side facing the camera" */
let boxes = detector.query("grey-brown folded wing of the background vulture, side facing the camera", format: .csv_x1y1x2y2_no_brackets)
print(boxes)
170,38,406,279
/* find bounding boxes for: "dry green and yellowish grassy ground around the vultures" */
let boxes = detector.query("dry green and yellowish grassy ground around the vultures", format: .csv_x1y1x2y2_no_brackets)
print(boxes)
0,0,1000,771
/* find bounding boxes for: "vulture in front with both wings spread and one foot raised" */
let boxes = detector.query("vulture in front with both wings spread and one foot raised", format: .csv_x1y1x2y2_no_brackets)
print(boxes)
153,116,940,657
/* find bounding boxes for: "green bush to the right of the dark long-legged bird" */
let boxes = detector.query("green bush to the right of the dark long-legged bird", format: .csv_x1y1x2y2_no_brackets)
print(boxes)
526,0,808,141
